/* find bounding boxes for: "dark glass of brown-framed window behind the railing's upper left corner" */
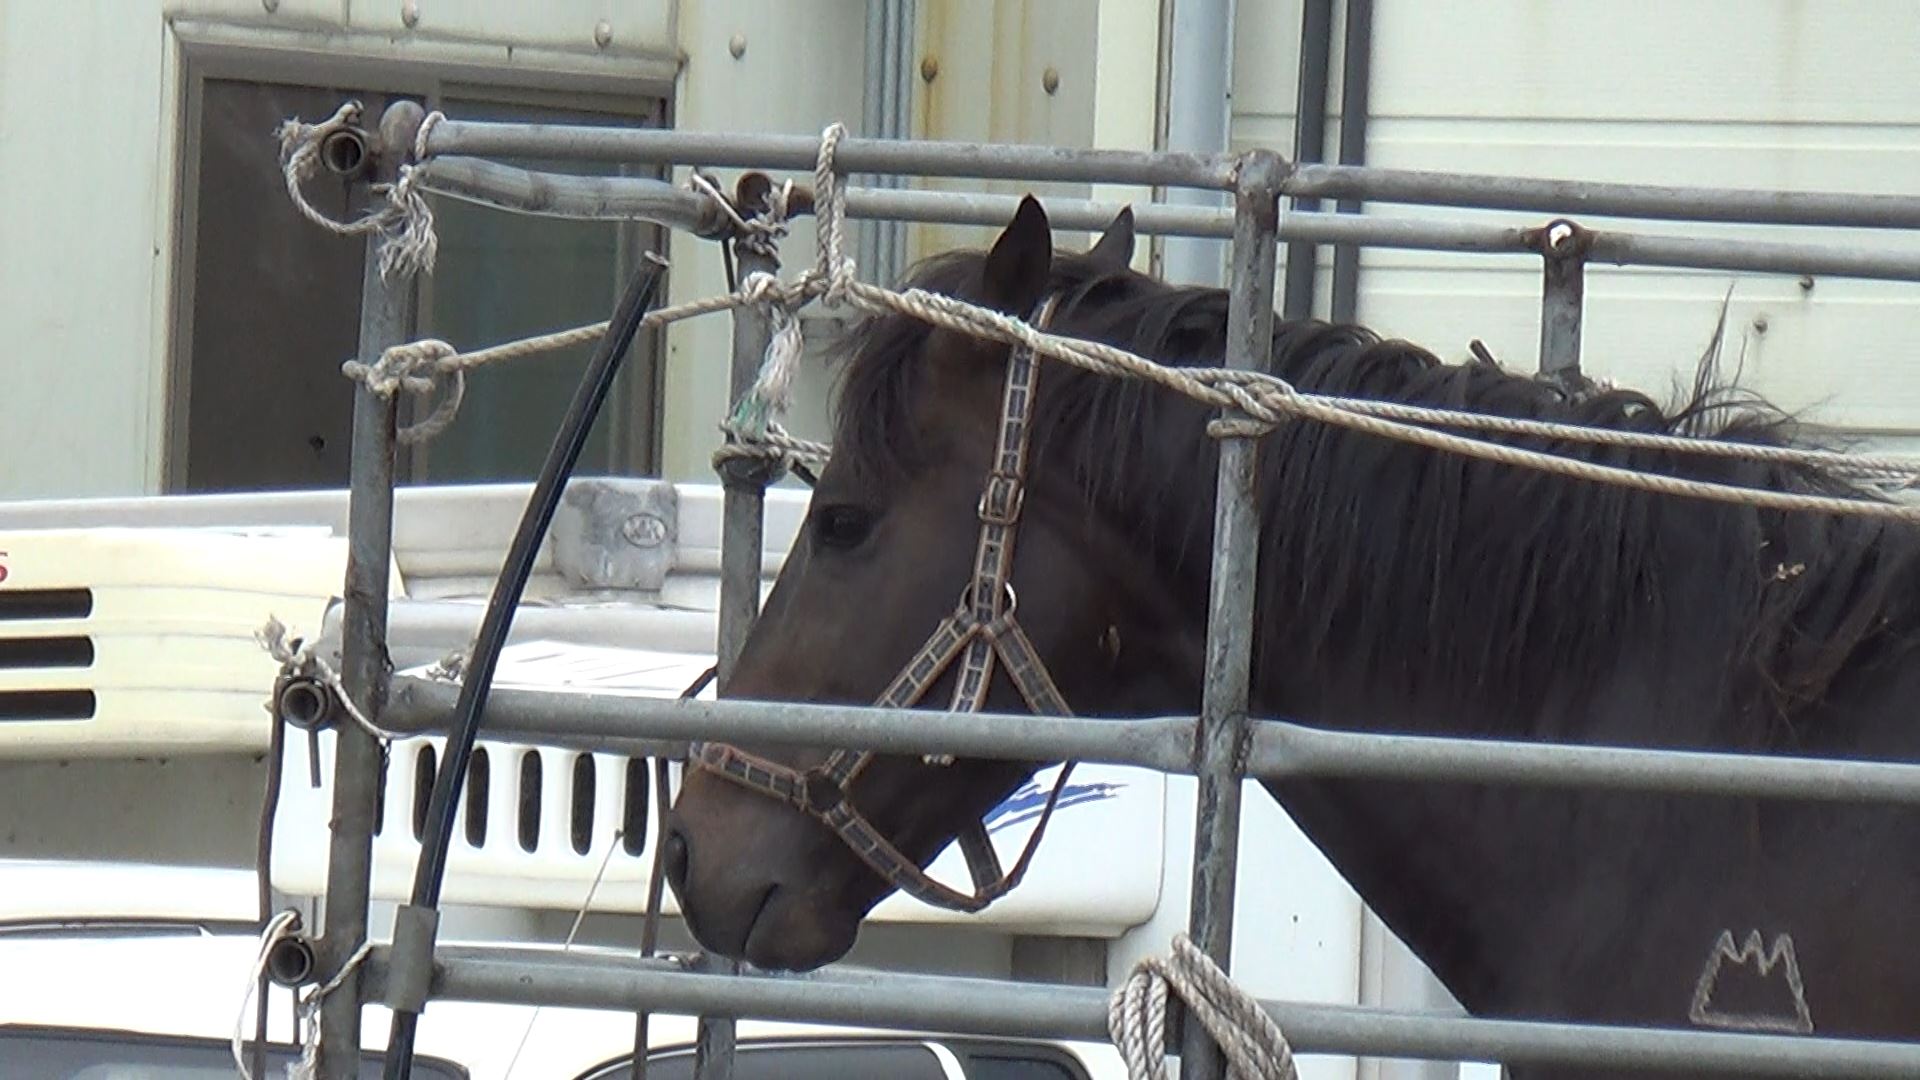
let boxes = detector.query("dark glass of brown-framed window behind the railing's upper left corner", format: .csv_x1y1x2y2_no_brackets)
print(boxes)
169,71,664,492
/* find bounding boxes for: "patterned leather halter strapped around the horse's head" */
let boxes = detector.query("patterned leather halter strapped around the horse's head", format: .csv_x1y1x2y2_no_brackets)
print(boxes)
687,298,1073,911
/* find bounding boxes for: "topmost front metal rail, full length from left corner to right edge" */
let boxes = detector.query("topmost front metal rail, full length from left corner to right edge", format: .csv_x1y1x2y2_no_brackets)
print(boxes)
426,119,1920,229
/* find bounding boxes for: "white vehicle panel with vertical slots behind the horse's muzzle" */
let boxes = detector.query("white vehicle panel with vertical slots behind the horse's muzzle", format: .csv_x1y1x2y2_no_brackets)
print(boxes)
273,642,1165,936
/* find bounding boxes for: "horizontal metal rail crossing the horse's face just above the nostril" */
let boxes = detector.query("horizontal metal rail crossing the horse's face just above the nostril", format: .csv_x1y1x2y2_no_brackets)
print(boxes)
382,678,1920,805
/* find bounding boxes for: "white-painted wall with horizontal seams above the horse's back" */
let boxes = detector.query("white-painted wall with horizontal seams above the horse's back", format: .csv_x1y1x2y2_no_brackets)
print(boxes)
1235,0,1920,440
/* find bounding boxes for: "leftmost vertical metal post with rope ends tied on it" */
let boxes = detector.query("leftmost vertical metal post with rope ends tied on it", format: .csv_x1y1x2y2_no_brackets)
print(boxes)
315,102,424,1080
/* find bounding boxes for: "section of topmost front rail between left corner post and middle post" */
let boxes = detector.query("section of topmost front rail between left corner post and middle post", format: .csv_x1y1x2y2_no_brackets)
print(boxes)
426,119,1238,190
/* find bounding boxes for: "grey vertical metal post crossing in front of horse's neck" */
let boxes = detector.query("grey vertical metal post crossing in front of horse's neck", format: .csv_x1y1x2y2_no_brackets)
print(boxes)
1181,150,1288,1080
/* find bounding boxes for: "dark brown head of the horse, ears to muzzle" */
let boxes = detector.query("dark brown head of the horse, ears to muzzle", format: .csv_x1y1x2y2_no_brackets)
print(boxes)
664,198,1200,970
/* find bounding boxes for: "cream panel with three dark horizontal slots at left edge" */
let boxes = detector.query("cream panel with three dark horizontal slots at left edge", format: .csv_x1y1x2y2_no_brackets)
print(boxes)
0,528,366,757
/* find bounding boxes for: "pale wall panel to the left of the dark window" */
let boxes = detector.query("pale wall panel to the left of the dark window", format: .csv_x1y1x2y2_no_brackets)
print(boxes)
0,0,167,496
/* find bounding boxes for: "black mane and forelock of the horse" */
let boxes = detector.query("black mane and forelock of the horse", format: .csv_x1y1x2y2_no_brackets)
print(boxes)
833,252,1920,748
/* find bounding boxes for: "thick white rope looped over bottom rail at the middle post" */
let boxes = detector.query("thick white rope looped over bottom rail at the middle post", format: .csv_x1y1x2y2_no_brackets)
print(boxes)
1106,934,1298,1080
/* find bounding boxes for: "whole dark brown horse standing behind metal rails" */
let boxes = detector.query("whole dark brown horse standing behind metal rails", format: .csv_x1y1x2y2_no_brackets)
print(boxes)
668,200,1920,1076
